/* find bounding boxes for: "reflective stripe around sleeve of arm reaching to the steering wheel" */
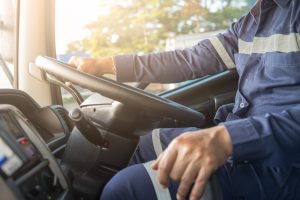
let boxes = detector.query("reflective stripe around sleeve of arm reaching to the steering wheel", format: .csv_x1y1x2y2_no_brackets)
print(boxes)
209,37,235,69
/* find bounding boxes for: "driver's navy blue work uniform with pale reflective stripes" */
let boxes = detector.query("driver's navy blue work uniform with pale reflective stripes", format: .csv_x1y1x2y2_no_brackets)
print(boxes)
103,0,300,199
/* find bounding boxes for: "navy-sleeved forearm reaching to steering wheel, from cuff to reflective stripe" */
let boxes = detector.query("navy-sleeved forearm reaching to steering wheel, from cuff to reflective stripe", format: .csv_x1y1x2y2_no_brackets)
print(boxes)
114,40,226,83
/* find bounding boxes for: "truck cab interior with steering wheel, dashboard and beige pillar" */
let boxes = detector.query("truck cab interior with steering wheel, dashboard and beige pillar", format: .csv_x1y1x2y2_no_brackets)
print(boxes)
0,0,245,200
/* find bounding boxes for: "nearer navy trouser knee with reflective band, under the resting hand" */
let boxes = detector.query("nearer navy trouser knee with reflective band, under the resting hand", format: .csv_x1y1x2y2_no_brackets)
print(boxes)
101,161,178,200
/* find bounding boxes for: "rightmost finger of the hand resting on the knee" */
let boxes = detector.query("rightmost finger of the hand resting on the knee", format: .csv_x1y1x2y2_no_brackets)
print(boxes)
190,166,212,200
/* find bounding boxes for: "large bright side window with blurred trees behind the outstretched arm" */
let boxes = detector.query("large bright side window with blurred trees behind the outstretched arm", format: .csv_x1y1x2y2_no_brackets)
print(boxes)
56,0,255,109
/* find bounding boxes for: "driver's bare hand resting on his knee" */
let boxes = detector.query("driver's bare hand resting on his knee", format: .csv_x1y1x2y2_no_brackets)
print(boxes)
152,125,233,200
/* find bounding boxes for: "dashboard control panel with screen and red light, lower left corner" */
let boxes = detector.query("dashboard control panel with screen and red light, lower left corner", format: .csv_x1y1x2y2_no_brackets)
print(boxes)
0,105,68,200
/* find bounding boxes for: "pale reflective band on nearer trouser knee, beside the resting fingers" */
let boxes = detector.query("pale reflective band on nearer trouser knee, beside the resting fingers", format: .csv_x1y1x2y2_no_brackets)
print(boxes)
143,161,171,200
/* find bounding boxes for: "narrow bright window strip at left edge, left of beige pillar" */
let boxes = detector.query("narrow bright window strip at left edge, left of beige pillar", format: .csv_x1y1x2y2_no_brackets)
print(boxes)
0,0,18,88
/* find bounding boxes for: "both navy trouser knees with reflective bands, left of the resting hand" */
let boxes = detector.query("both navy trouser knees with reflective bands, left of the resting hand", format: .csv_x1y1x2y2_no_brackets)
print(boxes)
101,128,197,200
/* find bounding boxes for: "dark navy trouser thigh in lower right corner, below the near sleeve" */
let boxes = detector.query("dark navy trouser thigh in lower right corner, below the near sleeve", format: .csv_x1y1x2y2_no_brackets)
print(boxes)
218,163,300,200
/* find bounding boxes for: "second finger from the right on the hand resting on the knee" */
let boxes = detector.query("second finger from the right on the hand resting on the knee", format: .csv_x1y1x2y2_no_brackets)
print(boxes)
176,163,199,200
